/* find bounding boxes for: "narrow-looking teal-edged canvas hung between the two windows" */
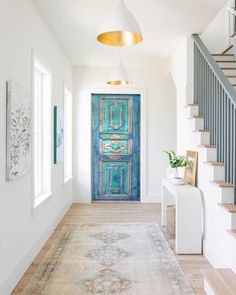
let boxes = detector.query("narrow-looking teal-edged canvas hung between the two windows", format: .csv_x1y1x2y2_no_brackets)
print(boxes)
54,106,64,164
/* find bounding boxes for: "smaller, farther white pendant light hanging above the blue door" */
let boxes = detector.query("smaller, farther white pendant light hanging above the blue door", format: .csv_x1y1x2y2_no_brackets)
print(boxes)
107,50,133,86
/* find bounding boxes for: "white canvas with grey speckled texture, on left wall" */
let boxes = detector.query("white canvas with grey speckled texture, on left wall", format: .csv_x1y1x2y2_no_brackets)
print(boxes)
6,81,31,181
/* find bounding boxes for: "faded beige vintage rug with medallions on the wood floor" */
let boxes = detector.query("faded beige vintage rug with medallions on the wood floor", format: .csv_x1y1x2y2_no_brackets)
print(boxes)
22,223,193,295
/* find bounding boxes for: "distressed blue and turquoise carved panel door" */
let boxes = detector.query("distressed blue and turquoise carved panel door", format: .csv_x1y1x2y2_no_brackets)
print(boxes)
92,94,140,201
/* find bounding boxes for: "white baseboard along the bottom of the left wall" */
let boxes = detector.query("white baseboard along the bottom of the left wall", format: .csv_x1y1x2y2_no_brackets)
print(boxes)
0,198,72,295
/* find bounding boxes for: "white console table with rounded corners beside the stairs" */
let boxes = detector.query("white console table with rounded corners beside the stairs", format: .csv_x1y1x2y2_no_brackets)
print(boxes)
162,179,202,254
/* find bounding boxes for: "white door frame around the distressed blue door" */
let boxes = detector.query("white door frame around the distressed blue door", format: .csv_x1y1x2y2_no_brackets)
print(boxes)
84,87,147,202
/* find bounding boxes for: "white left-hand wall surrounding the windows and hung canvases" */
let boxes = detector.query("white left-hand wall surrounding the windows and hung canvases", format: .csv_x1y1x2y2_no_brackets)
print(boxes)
0,0,72,295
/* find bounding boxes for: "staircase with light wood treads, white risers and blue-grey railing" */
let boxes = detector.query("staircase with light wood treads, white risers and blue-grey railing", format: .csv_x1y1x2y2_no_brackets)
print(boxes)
185,35,236,295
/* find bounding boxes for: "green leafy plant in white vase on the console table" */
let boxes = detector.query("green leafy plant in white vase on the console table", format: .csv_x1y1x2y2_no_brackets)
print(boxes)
165,150,186,185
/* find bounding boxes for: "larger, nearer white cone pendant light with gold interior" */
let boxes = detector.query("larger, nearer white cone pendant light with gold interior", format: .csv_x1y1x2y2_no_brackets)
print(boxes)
97,0,143,47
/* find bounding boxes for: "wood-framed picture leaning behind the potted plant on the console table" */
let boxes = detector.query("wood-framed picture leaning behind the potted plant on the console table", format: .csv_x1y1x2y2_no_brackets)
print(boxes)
184,151,198,186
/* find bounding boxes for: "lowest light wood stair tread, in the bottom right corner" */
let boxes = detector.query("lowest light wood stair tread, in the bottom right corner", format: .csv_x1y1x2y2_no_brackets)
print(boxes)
204,269,235,295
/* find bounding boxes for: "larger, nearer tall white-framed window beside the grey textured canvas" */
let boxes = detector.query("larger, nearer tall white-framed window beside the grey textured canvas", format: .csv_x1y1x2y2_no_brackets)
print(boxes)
34,59,51,206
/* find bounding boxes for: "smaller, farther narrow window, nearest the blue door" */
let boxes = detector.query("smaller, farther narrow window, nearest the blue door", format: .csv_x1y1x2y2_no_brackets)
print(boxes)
64,89,72,182
